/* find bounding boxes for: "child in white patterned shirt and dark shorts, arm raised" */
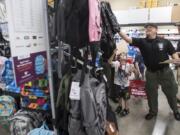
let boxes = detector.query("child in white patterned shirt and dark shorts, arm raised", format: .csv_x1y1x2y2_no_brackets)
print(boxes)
108,50,133,116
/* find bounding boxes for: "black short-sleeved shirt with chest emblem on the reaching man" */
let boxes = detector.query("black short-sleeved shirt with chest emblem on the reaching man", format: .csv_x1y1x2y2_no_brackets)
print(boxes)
132,38,175,72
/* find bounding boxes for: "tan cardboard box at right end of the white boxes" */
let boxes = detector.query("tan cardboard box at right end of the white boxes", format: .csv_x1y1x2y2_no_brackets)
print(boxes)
171,6,180,23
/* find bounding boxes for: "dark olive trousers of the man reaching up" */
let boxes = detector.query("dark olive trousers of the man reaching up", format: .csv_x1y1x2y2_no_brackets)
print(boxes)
146,67,178,114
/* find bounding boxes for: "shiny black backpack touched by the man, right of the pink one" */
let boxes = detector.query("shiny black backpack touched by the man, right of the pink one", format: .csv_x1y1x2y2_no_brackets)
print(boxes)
101,2,120,62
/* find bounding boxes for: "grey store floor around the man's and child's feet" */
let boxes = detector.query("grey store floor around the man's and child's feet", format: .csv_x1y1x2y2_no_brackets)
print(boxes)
111,90,180,135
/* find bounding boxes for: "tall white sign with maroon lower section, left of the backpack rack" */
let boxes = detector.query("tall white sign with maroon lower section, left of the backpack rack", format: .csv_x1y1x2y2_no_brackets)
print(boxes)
6,0,48,85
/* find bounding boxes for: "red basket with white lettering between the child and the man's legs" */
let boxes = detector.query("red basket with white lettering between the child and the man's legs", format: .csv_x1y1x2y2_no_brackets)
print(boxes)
129,80,146,98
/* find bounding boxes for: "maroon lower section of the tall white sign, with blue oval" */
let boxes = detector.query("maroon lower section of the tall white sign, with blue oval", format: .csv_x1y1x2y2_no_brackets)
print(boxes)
13,51,47,84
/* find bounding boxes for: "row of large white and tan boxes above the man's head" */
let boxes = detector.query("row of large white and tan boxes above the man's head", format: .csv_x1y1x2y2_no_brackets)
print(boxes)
113,6,180,26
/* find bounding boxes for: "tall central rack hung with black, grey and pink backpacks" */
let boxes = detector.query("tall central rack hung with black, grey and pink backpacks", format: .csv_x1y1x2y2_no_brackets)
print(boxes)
49,0,120,135
